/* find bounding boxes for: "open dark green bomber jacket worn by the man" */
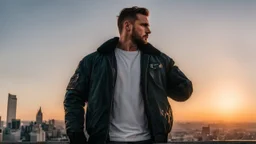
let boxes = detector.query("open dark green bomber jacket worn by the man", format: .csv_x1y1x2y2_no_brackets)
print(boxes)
64,37,193,144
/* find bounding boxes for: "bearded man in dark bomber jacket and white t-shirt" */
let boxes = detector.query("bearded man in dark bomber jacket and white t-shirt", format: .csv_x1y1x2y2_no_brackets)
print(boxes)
64,7,193,144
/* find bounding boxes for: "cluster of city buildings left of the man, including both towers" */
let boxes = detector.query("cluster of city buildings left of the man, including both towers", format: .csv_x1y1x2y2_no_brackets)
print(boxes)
0,93,68,142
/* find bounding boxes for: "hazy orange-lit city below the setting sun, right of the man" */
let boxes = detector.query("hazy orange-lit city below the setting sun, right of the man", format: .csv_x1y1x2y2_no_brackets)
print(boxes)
168,122,256,142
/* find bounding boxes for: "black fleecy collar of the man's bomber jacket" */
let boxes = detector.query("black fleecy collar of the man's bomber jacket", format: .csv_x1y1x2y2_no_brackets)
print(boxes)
97,37,161,55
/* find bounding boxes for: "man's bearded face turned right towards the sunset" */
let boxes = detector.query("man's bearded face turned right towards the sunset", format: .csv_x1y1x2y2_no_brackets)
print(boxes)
131,14,151,44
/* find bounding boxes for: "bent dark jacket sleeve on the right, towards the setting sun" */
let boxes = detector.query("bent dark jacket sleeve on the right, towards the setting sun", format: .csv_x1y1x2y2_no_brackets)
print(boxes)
166,56,193,102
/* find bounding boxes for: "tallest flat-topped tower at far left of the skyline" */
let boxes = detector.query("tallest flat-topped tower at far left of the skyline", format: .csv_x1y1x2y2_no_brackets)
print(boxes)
6,93,17,127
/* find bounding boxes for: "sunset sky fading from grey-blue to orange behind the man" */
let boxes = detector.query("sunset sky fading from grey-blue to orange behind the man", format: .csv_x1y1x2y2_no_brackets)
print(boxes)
0,0,256,122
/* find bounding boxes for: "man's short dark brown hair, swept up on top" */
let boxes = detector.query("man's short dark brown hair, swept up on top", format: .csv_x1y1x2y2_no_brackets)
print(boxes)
117,6,149,33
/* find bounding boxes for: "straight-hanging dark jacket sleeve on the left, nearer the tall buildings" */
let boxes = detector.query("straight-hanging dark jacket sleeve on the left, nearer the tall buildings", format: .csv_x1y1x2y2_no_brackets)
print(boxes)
64,58,90,144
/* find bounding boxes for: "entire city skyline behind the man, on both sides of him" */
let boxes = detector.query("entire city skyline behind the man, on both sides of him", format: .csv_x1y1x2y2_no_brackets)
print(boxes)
0,94,256,142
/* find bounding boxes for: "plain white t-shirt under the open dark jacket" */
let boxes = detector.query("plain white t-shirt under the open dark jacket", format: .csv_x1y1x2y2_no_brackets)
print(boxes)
109,48,151,142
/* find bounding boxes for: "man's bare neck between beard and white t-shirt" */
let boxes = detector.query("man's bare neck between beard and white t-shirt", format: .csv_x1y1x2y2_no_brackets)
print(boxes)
117,37,138,51
